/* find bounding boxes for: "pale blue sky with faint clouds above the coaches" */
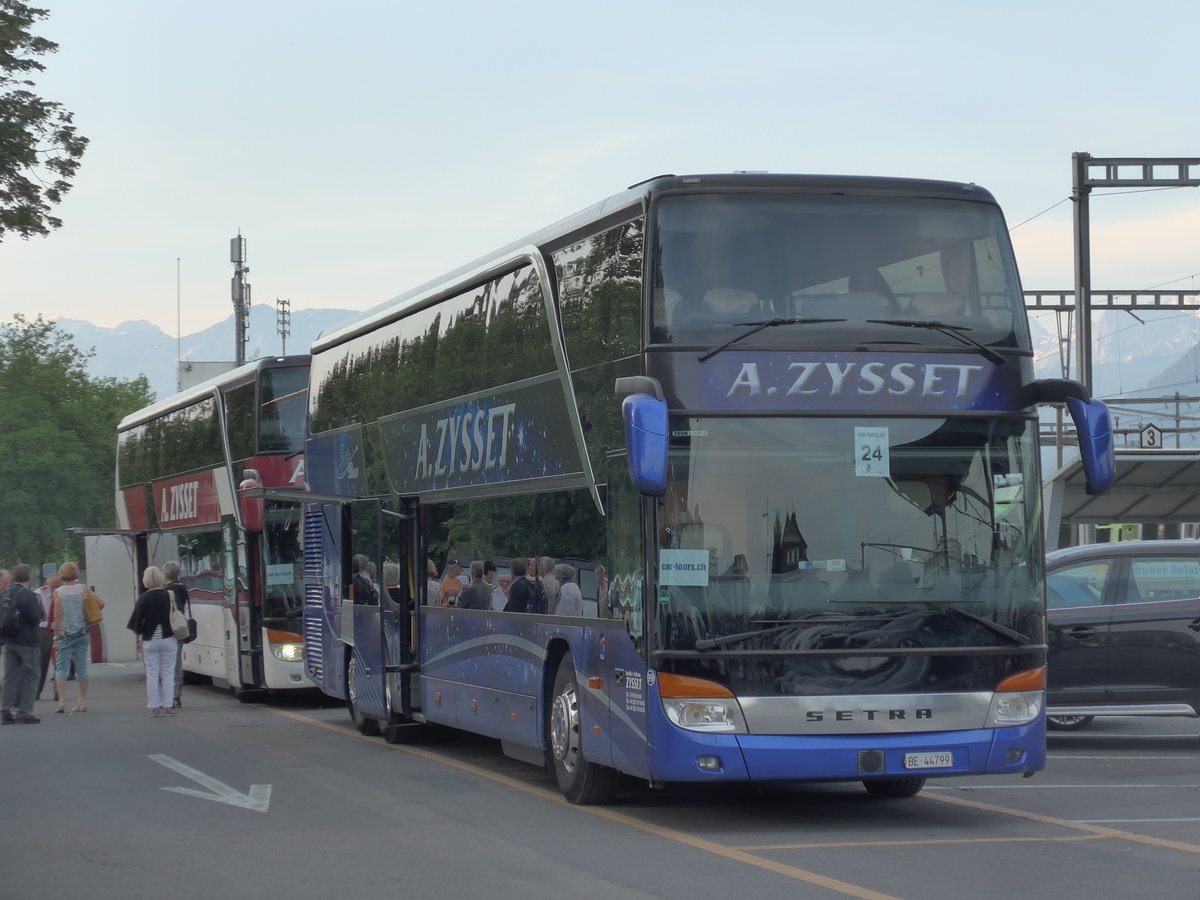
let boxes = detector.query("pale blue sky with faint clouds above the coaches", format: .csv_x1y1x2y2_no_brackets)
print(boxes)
0,0,1200,335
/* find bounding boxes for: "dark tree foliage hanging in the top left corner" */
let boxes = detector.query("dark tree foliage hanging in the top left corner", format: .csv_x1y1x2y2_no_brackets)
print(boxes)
0,0,88,241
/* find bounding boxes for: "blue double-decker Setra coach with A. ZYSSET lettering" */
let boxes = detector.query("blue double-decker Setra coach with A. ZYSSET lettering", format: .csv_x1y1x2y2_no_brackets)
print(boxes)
285,174,1112,803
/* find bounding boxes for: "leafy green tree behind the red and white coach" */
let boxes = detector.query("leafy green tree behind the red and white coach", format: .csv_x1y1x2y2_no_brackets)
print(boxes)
0,316,154,565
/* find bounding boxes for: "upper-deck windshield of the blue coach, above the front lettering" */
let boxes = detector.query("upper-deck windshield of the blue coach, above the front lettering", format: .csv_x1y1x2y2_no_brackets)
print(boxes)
650,193,1028,348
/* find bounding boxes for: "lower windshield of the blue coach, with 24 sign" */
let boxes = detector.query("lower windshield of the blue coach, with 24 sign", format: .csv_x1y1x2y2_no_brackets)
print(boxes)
654,416,1044,650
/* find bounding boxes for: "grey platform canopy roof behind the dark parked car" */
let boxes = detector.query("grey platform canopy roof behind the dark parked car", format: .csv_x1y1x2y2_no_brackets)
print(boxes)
1044,448,1200,547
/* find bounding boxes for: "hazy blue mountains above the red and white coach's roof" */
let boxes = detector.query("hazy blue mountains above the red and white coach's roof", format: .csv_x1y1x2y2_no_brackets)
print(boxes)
58,304,356,400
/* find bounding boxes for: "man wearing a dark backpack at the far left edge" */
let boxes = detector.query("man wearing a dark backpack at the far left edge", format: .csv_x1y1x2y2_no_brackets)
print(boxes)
0,563,46,725
